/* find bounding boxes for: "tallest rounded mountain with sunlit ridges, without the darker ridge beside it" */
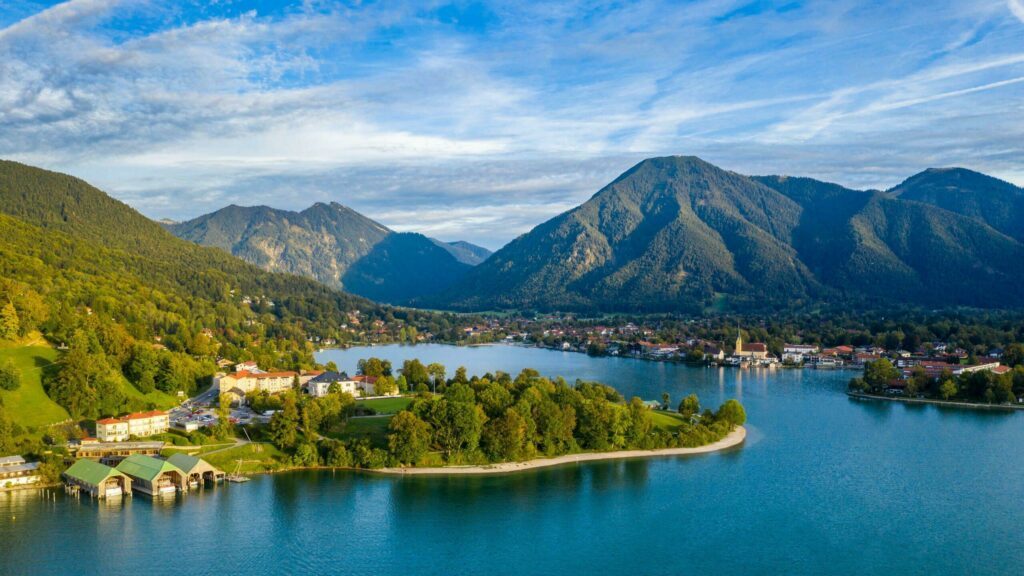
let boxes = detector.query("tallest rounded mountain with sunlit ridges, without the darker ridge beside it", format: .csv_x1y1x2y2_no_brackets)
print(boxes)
432,157,819,311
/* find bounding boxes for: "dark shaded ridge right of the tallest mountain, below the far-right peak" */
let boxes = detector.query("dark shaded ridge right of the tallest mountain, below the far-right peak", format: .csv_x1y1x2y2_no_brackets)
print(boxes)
754,176,1024,306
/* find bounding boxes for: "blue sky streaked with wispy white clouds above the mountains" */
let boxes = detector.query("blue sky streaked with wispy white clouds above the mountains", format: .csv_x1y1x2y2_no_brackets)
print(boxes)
0,0,1024,249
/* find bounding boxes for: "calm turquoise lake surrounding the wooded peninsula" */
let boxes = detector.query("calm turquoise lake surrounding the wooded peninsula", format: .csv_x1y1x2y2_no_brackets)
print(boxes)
0,345,1024,574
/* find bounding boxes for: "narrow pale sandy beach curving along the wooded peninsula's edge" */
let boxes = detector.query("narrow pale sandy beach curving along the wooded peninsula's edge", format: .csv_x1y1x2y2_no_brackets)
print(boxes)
369,426,746,475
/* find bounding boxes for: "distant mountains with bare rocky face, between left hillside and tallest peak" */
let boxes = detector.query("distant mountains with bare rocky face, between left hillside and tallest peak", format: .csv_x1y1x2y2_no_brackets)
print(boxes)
167,202,489,303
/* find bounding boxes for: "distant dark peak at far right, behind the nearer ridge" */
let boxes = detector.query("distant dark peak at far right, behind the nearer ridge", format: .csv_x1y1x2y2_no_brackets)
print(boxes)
889,168,1024,242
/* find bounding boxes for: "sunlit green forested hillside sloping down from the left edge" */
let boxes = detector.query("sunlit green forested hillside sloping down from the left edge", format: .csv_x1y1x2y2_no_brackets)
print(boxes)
0,161,444,418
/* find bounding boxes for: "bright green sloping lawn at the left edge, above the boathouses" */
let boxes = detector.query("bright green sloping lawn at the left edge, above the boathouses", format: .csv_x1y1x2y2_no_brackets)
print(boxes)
0,345,70,427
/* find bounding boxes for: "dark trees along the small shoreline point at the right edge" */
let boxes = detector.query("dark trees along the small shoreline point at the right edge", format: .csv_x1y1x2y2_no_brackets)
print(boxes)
849,359,1024,404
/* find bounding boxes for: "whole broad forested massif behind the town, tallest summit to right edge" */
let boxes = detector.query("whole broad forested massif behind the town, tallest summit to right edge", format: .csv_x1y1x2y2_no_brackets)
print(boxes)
423,157,1024,312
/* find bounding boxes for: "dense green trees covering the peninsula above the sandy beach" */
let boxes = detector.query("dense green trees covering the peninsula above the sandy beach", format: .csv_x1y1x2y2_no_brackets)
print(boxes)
260,361,746,468
